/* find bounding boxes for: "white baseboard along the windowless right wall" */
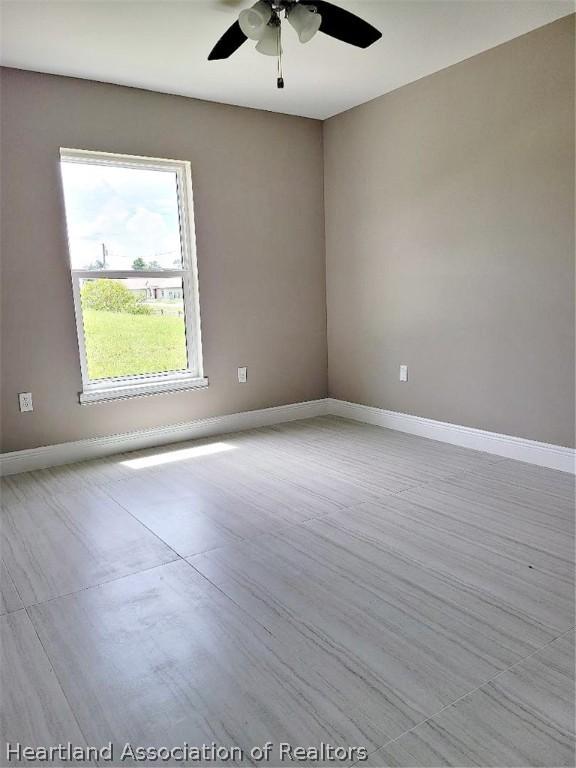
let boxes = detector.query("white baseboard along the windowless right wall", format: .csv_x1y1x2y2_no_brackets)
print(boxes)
327,398,576,474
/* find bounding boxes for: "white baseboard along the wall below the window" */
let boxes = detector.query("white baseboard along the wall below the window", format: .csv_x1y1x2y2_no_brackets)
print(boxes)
0,400,327,477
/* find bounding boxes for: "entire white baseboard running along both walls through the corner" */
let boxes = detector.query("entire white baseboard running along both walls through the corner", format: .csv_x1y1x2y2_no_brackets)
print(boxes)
0,398,576,476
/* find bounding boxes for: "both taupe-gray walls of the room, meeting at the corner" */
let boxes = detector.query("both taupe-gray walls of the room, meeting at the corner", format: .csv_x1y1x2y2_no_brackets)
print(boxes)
1,17,574,451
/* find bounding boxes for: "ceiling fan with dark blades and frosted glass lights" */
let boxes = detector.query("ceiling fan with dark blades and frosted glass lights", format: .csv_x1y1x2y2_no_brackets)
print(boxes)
208,0,382,88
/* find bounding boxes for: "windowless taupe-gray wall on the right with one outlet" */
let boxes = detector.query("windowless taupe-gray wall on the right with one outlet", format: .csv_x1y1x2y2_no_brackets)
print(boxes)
324,16,574,446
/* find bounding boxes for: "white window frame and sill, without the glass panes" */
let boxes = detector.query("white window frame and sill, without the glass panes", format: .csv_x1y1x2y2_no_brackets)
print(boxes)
60,147,208,404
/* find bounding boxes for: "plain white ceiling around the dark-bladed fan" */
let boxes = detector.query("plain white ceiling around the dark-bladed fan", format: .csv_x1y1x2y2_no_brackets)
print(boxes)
0,0,575,119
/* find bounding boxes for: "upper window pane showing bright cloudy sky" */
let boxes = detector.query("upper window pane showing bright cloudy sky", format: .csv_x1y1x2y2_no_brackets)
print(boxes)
61,160,182,270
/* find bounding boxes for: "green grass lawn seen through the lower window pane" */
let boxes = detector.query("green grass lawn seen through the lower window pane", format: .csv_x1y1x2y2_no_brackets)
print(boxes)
83,309,186,379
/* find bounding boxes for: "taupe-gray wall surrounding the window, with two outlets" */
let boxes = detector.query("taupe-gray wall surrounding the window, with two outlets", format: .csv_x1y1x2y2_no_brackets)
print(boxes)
1,69,327,451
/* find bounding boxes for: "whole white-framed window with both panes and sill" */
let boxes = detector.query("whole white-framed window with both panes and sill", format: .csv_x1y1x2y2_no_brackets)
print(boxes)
60,149,208,403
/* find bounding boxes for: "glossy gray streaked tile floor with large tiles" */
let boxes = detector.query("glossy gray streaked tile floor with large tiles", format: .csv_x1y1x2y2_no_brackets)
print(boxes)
0,417,575,768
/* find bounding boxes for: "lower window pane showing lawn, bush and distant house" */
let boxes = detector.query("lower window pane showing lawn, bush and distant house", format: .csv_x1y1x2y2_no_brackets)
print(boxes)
80,277,188,381
